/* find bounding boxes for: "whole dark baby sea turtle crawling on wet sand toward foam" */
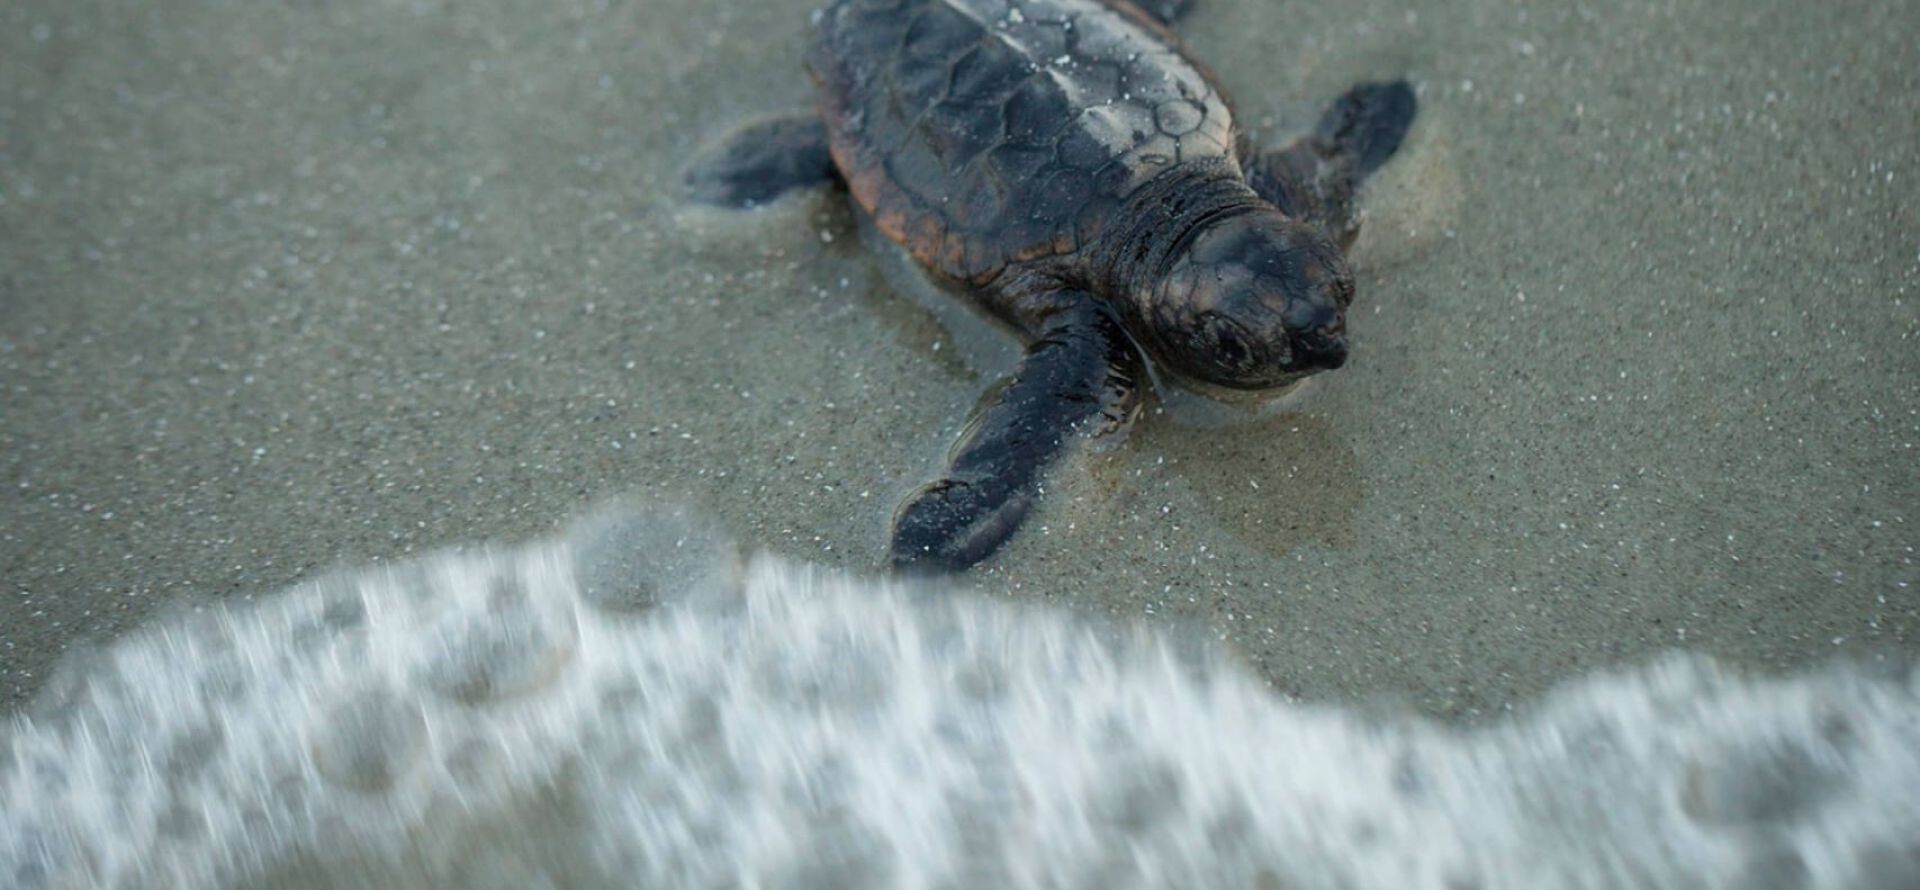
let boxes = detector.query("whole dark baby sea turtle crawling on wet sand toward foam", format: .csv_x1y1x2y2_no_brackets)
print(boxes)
687,0,1415,570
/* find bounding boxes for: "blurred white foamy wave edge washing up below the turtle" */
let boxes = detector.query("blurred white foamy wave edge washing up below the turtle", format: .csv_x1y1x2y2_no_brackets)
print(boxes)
0,510,1920,888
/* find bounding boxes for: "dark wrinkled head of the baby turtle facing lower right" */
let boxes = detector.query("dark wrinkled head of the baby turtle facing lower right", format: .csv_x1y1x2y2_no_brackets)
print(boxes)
1142,211,1354,389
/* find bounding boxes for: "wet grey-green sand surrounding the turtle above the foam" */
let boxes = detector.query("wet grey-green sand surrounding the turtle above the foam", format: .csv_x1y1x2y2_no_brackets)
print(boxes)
0,0,1920,719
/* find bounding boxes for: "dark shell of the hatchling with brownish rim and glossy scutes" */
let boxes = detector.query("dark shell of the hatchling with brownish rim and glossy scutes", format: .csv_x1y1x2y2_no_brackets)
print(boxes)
808,0,1240,284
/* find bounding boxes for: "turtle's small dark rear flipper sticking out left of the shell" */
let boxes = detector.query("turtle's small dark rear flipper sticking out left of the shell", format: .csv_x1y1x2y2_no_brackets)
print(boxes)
685,115,837,209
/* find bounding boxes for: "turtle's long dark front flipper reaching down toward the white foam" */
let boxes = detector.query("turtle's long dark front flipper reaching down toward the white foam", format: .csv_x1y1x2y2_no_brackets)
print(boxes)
891,303,1142,572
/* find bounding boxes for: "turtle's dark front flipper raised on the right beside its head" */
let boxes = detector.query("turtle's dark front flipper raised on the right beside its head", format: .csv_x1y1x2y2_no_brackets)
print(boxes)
1248,81,1419,249
